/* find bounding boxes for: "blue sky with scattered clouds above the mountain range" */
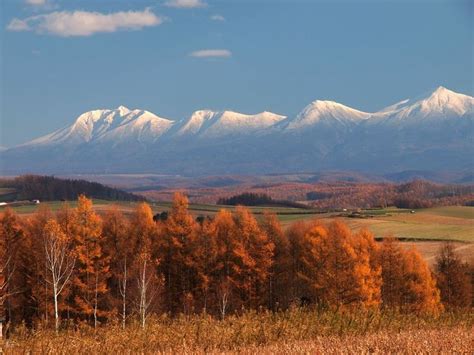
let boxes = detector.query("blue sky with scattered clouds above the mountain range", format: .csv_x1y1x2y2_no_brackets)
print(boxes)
0,0,474,147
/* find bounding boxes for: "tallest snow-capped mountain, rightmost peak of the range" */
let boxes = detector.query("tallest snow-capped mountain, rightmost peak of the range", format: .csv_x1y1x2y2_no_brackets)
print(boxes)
334,87,474,171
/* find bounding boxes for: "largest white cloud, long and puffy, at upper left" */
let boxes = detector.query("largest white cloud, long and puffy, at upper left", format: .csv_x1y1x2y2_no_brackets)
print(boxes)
7,9,164,37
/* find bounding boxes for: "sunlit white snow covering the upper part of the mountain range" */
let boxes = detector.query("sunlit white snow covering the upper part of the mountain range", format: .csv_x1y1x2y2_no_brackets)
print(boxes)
12,86,474,152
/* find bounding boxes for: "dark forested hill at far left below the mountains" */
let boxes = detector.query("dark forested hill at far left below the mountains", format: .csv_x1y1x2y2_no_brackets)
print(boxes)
0,175,145,201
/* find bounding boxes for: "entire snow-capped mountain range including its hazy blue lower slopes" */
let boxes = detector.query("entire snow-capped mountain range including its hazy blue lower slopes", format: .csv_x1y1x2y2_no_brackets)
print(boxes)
0,87,474,175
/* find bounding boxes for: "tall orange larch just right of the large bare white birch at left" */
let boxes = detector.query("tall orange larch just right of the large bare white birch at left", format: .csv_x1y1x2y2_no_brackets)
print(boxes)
72,196,110,327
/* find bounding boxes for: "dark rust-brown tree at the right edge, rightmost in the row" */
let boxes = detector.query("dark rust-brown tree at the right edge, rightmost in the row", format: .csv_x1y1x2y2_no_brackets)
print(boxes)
435,242,473,308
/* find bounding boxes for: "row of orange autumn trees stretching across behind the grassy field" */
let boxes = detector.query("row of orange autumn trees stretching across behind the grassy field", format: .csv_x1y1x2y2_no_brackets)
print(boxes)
0,193,473,330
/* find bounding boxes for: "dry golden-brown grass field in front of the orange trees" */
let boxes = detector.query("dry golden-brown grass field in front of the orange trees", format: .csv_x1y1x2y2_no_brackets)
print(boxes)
0,308,474,354
